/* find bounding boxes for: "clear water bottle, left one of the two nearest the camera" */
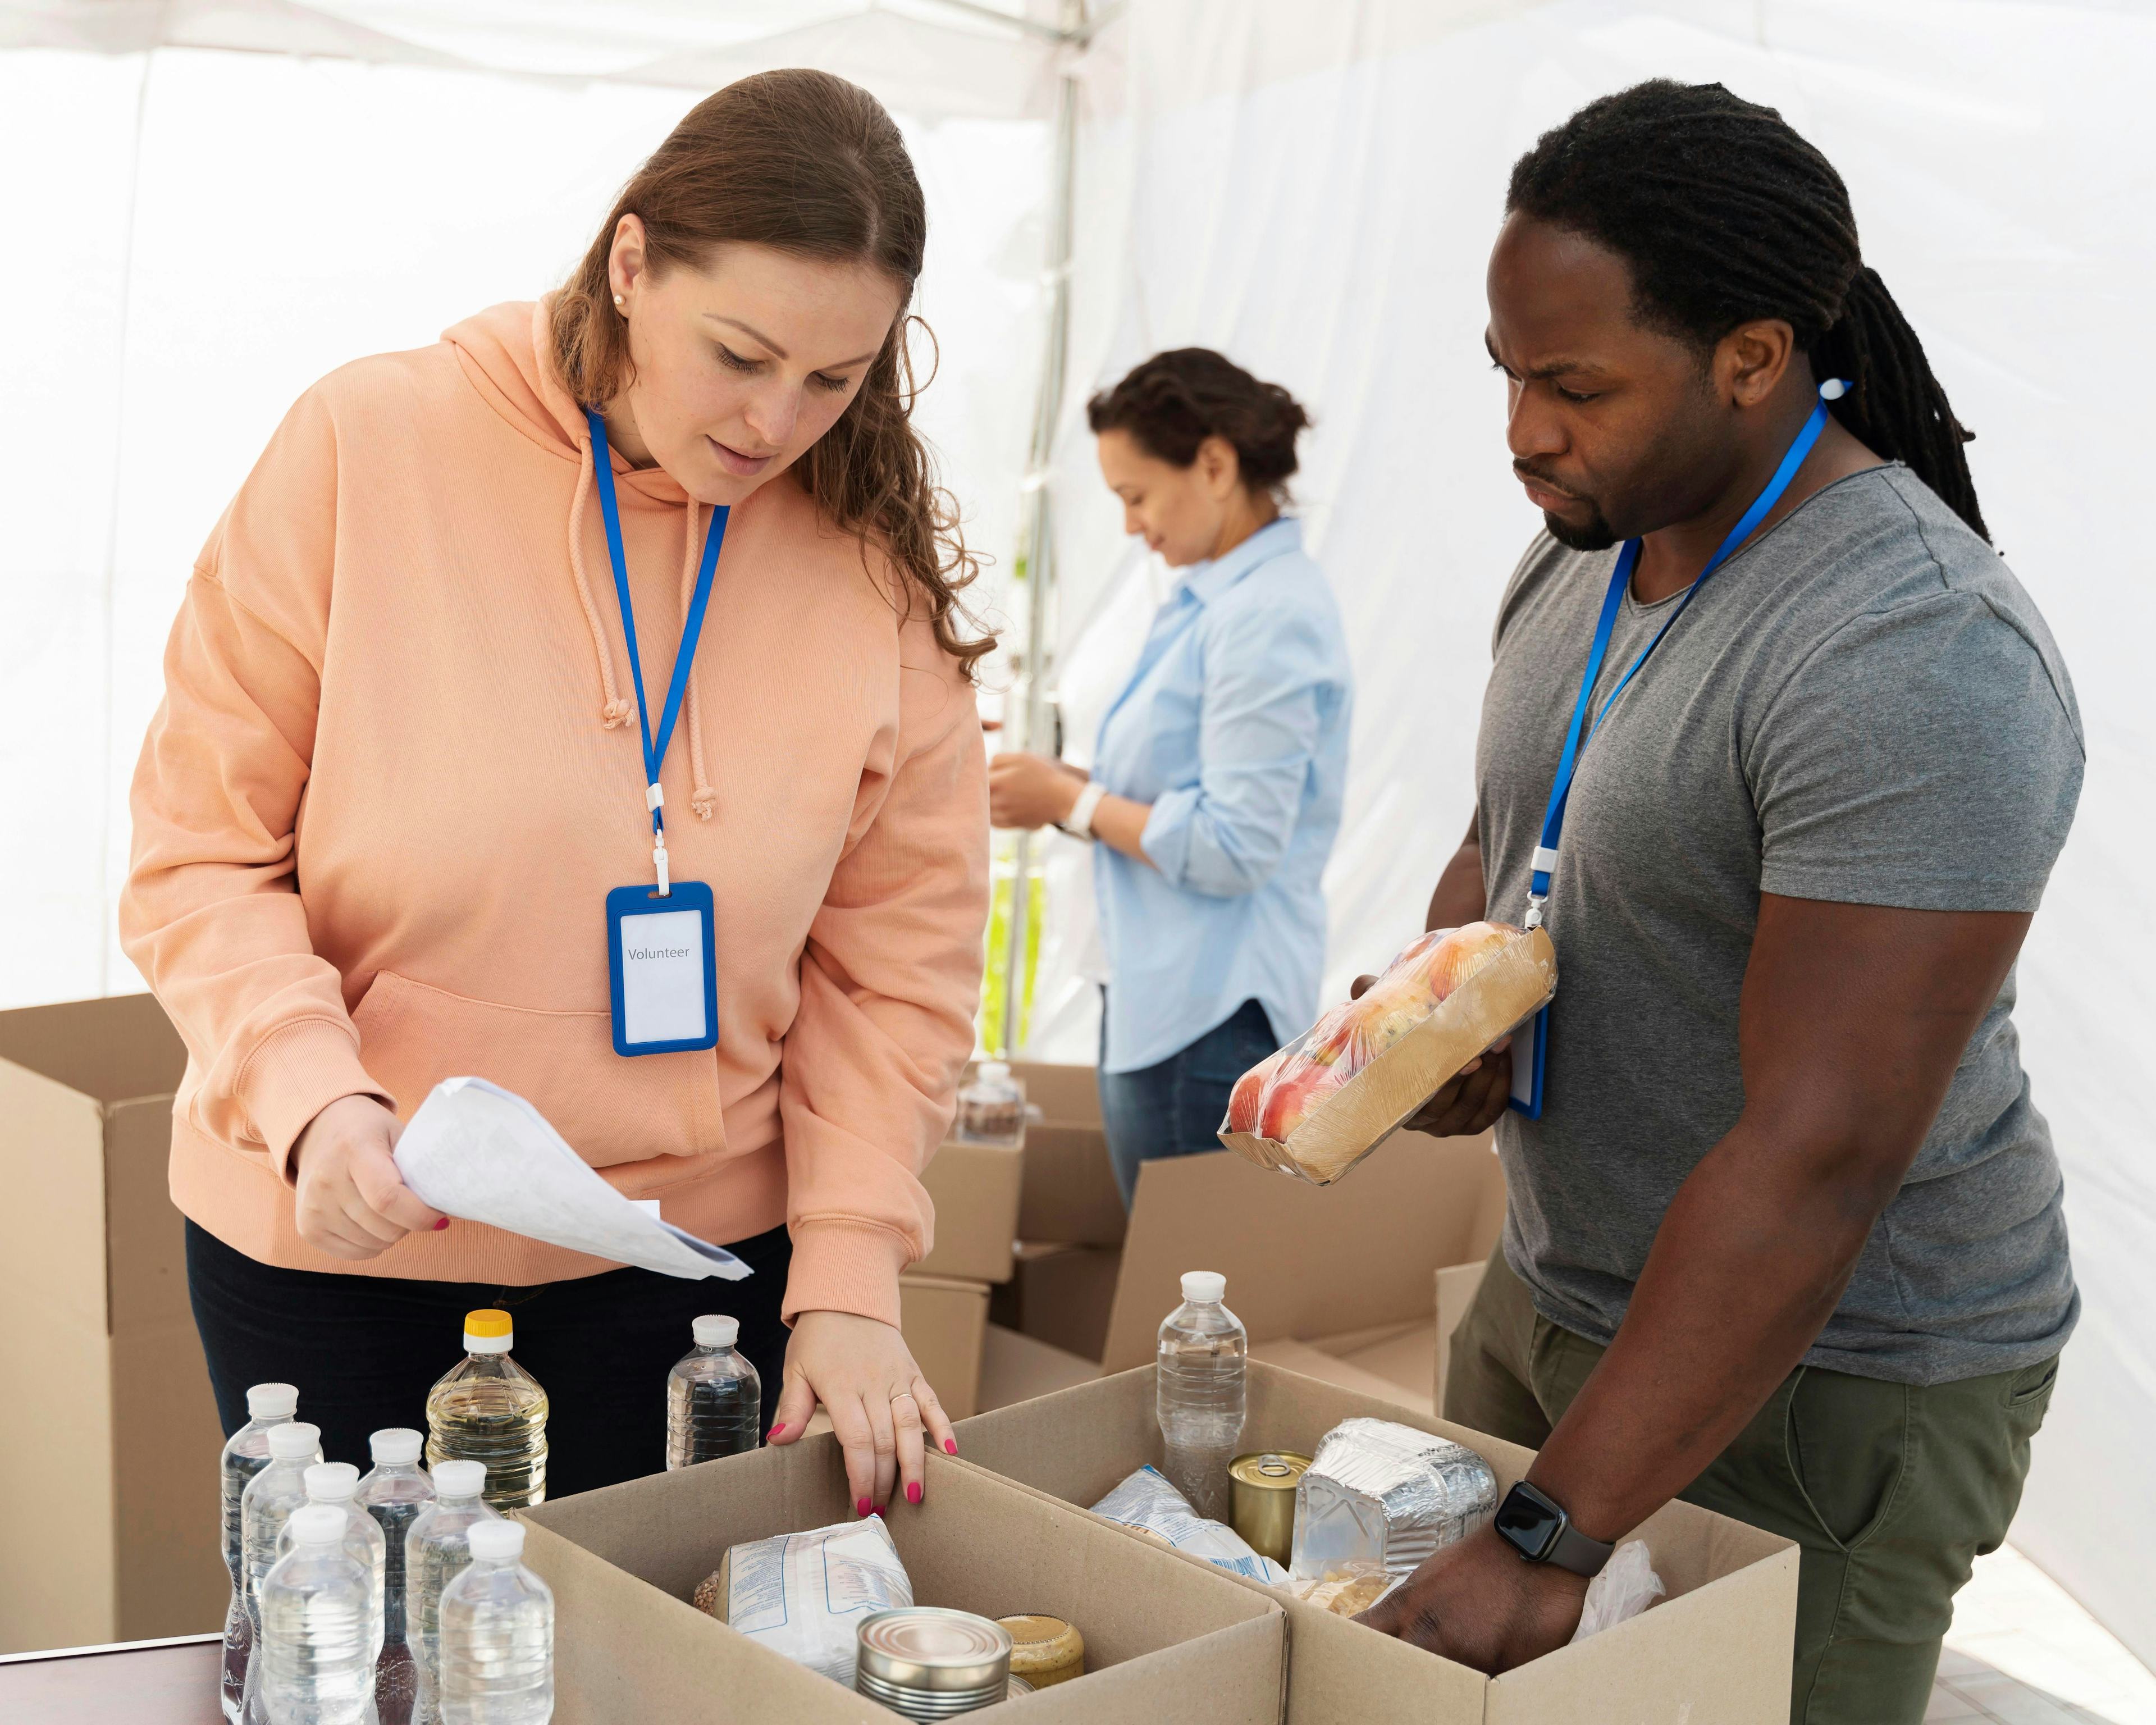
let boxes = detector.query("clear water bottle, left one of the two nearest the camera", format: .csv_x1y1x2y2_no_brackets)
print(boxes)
259,1503,375,1725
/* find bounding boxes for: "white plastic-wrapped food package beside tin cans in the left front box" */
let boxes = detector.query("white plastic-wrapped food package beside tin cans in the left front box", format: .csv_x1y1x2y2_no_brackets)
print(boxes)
696,1516,914,1689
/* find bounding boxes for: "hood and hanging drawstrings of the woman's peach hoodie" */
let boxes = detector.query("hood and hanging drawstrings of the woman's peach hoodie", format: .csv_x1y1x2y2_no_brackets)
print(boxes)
442,295,716,826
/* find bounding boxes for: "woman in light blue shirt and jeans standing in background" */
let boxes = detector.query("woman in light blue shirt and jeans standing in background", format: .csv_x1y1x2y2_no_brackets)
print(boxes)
990,347,1352,1203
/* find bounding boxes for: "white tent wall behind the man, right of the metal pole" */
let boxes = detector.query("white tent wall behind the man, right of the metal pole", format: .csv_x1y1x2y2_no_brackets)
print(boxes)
1035,0,2156,1660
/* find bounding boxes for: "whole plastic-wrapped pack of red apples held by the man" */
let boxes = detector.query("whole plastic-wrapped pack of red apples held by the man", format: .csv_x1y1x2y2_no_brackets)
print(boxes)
1220,923,1556,1186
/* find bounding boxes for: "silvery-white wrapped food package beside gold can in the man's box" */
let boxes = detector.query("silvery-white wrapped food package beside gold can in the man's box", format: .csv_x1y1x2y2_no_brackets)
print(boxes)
1289,1419,1496,1581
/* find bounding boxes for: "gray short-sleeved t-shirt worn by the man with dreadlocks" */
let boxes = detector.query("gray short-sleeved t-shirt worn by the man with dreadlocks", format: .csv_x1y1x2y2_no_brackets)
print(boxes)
1477,464,2082,1384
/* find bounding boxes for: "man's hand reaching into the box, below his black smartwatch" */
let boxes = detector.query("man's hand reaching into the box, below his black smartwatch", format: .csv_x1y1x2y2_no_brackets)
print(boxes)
1356,1527,1587,1678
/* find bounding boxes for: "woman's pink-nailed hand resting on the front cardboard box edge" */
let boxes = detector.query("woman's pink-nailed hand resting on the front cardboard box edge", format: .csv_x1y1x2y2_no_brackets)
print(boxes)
772,1311,957,1516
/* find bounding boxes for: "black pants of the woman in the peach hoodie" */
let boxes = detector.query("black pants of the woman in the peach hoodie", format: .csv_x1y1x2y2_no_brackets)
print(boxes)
188,1222,793,1499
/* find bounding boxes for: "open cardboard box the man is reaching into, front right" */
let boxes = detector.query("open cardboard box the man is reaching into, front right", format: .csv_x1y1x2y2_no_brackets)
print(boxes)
957,1363,1798,1725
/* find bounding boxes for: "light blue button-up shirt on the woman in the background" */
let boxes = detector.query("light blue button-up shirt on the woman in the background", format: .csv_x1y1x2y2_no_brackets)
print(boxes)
1093,519,1354,1071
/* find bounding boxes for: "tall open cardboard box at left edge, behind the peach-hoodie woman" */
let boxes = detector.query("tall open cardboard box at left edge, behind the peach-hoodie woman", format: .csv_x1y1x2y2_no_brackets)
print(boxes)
0,994,231,1651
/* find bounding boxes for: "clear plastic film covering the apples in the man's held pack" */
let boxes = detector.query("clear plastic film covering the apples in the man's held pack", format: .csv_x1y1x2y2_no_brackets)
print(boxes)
1225,923,1520,1140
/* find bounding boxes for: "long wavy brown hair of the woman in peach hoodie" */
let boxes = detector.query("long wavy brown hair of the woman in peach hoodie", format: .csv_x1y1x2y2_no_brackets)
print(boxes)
554,69,996,675
